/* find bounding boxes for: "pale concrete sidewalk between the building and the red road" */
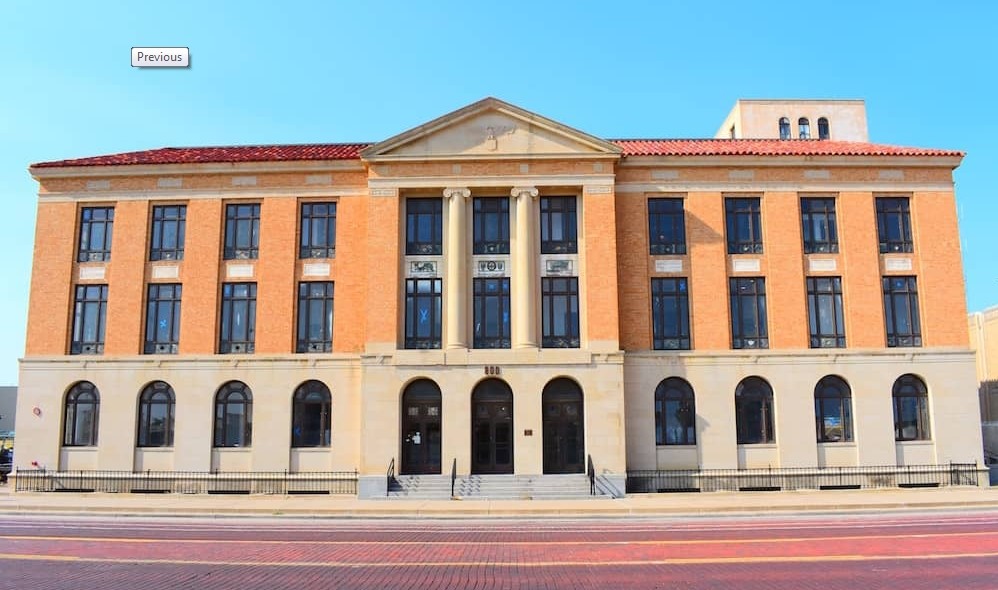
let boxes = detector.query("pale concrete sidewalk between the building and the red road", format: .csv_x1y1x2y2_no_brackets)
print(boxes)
0,485,998,518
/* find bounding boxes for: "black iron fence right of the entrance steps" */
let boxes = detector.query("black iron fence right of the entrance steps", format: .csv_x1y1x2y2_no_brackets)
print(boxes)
627,463,986,493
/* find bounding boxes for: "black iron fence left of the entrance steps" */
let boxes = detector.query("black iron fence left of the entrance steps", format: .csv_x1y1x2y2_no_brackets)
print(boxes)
12,470,357,494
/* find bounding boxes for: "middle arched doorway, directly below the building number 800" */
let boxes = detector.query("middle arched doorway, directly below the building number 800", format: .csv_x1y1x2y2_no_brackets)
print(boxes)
471,379,513,473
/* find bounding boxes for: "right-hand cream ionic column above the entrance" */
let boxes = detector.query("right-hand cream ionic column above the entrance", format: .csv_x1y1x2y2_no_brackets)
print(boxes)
510,186,538,348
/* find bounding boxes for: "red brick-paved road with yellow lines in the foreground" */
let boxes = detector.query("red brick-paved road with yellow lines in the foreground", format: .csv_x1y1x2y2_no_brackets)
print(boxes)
0,511,998,590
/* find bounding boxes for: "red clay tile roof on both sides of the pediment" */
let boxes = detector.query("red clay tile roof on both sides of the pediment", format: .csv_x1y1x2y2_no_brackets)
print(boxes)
32,139,964,168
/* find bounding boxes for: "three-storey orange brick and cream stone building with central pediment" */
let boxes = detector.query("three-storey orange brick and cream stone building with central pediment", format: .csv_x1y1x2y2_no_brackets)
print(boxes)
18,98,982,493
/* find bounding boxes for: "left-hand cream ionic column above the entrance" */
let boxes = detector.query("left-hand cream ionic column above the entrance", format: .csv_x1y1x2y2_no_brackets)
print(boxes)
443,188,471,348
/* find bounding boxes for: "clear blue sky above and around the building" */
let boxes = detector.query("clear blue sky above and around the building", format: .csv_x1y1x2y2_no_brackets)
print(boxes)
0,0,998,384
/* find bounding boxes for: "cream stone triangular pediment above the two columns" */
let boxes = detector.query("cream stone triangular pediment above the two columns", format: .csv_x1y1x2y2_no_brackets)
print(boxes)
361,98,620,161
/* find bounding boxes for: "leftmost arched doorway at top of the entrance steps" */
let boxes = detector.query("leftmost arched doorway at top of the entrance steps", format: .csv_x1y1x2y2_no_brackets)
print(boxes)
399,379,440,475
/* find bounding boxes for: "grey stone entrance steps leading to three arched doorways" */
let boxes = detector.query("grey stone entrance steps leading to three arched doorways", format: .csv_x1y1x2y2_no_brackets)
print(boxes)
388,474,608,500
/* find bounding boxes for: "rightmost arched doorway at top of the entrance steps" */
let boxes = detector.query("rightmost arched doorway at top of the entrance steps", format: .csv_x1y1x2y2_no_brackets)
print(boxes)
541,377,586,473
